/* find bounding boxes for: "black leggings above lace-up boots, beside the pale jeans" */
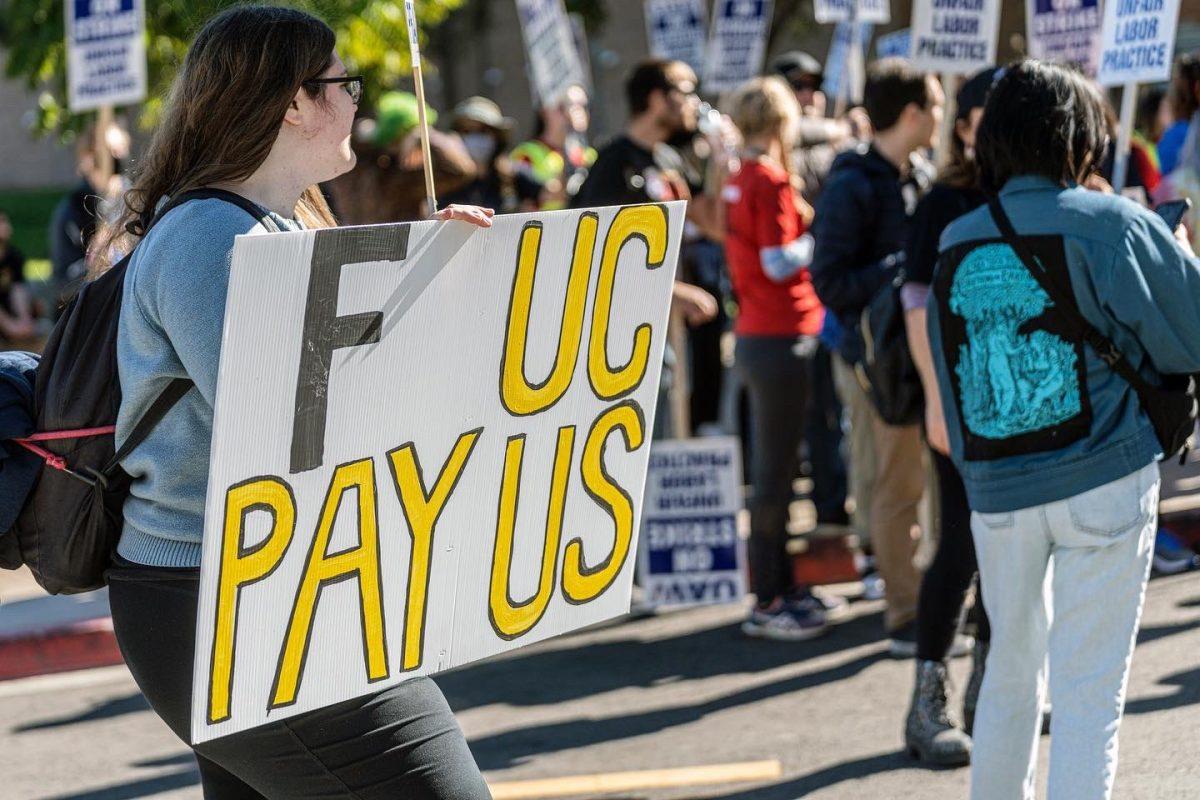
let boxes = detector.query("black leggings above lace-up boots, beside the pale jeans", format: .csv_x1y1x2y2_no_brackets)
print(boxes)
917,452,991,661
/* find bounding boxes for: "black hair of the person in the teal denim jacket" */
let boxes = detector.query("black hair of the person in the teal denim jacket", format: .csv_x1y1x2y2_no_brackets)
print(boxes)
976,59,1109,192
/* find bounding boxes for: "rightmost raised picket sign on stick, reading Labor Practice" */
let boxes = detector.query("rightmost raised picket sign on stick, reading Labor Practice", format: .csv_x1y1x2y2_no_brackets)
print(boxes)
1096,0,1180,192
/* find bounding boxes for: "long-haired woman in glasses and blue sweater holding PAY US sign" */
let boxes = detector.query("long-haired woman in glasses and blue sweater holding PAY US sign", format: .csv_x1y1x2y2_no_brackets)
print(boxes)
108,6,492,800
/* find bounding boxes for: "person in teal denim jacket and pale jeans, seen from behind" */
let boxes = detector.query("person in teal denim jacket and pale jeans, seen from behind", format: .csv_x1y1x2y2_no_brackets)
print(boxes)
926,61,1200,800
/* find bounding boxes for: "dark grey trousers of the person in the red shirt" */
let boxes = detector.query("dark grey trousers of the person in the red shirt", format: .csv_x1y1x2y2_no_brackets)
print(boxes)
734,336,817,604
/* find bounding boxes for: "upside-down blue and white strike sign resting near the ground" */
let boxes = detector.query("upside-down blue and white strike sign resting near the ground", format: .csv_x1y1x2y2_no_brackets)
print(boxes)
638,437,746,607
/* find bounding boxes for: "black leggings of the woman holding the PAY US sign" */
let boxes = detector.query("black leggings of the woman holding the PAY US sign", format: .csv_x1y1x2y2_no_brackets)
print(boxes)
108,560,492,800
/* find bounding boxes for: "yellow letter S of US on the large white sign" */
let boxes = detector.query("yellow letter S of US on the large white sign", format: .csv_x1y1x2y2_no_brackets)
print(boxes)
563,401,646,603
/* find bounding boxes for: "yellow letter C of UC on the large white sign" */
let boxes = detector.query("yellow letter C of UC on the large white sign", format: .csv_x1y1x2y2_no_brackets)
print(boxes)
588,205,667,399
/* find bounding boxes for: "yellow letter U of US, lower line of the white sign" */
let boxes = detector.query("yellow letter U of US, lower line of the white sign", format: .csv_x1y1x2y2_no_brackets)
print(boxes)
488,426,575,639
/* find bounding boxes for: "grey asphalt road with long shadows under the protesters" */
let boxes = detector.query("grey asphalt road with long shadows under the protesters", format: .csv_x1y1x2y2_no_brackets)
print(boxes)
0,573,1200,800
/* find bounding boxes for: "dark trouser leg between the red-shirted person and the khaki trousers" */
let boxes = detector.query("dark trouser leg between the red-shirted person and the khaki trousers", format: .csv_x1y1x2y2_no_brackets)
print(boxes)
804,344,850,525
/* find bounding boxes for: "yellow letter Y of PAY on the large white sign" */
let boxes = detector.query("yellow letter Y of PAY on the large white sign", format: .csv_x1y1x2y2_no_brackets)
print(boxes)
388,428,484,670
